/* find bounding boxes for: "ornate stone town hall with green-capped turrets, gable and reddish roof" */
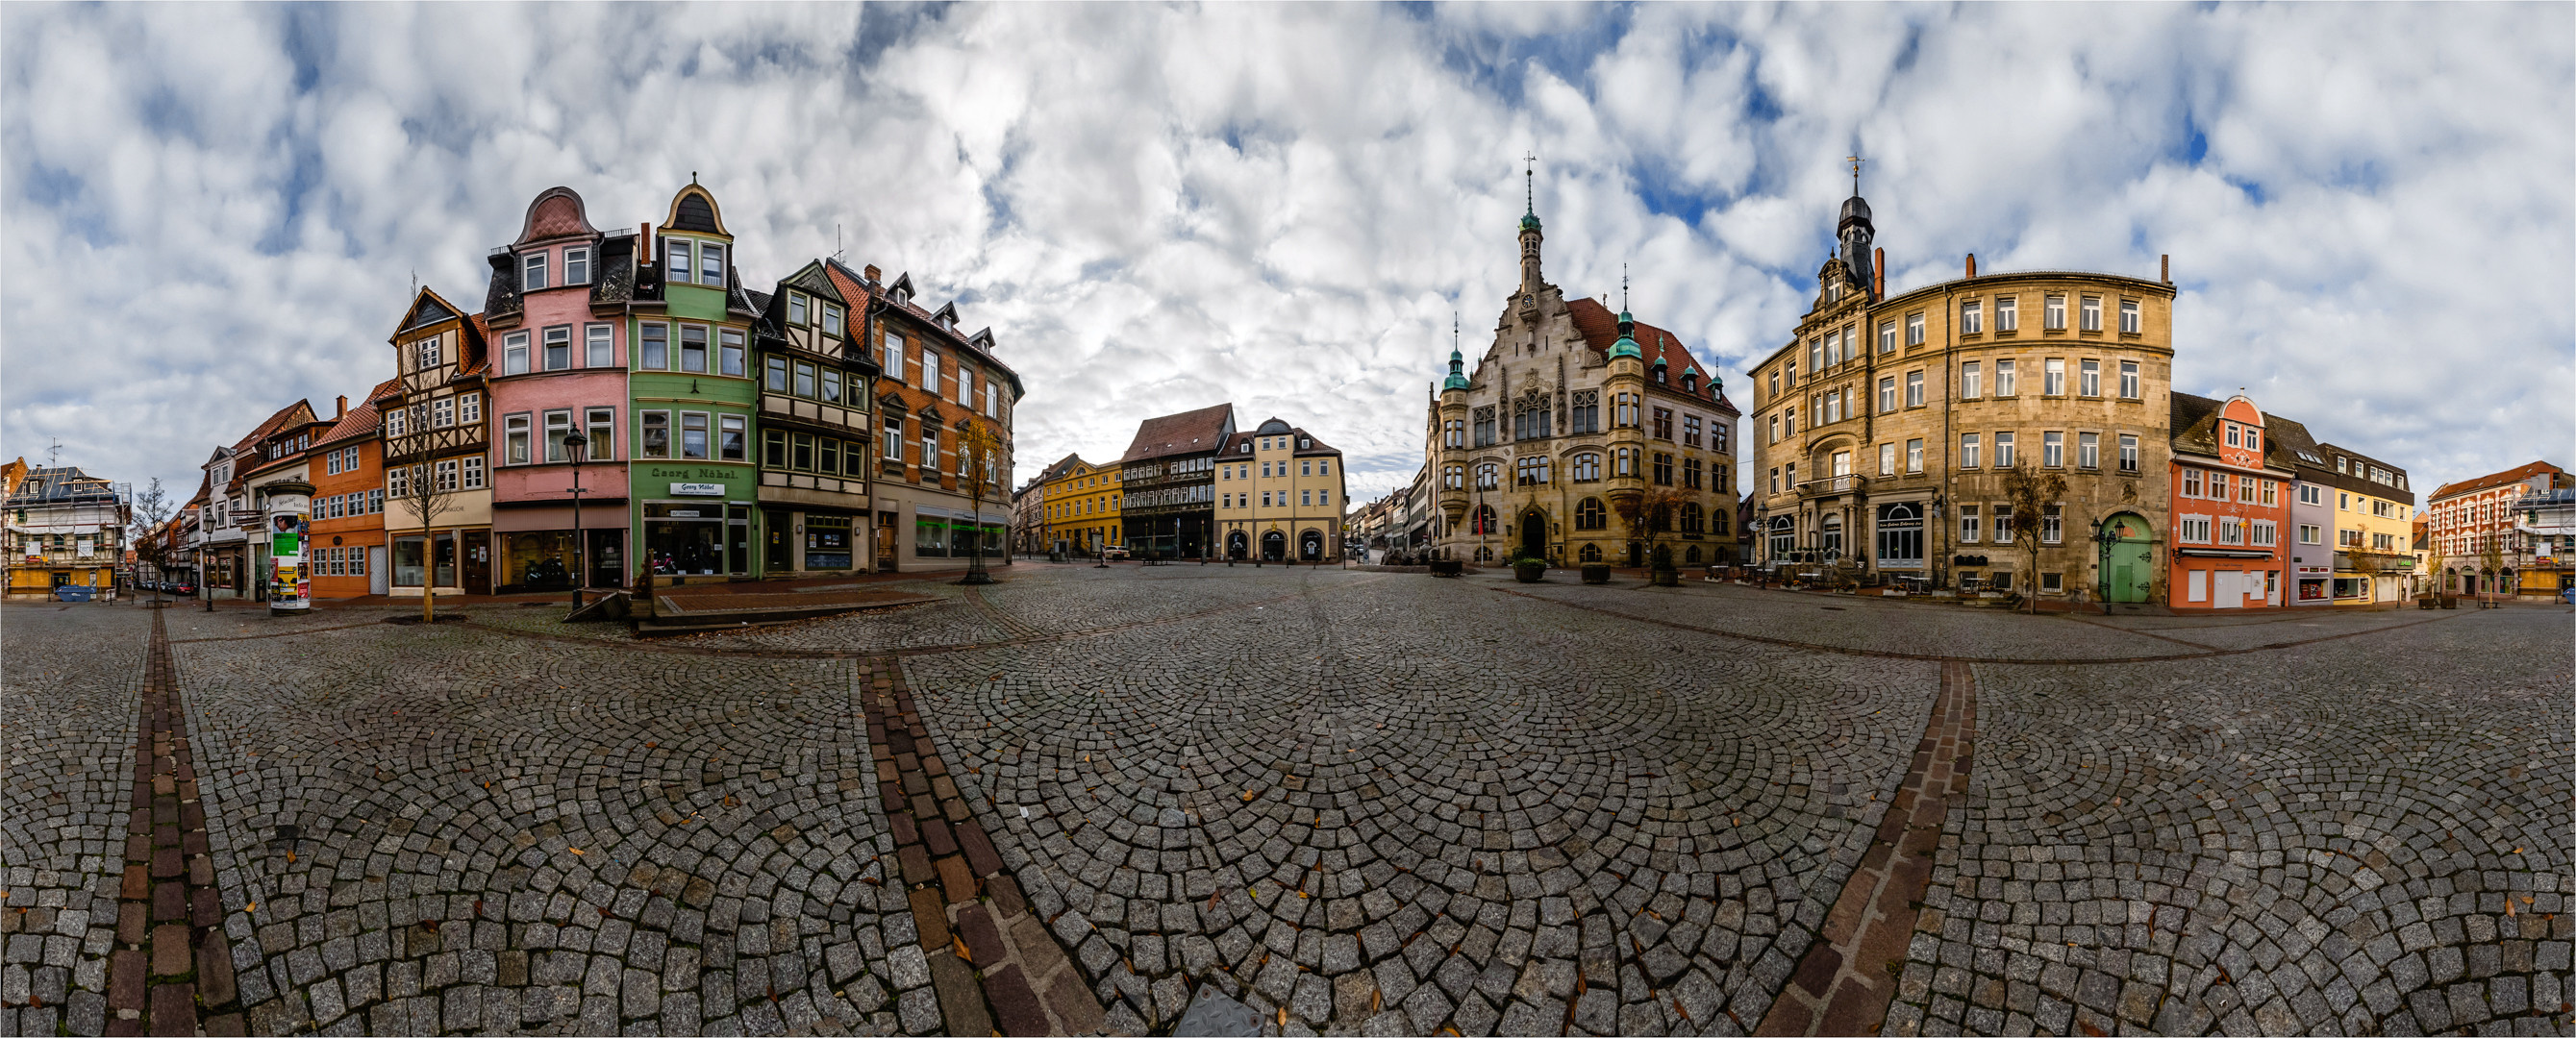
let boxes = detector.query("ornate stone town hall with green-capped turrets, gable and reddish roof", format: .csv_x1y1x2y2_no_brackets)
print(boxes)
1424,180,1738,564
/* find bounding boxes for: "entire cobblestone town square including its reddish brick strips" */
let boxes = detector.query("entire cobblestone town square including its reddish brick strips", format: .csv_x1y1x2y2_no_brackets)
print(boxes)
0,574,2576,1035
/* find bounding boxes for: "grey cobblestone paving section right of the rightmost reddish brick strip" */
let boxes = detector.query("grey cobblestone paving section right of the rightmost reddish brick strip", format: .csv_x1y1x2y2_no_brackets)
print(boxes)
1886,610,2576,1033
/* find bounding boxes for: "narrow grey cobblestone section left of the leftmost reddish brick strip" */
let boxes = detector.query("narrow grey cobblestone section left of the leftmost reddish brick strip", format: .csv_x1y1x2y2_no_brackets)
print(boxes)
0,606,152,1035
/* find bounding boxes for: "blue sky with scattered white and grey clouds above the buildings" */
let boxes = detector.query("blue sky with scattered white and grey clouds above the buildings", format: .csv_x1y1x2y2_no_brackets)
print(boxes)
0,5,2576,507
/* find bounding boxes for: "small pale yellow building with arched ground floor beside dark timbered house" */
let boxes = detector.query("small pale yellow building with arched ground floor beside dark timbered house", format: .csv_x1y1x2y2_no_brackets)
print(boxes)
1215,417,1350,561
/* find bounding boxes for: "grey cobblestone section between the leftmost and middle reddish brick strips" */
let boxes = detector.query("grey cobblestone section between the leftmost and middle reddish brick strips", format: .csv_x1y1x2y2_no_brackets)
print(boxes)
181,626,916,1033
